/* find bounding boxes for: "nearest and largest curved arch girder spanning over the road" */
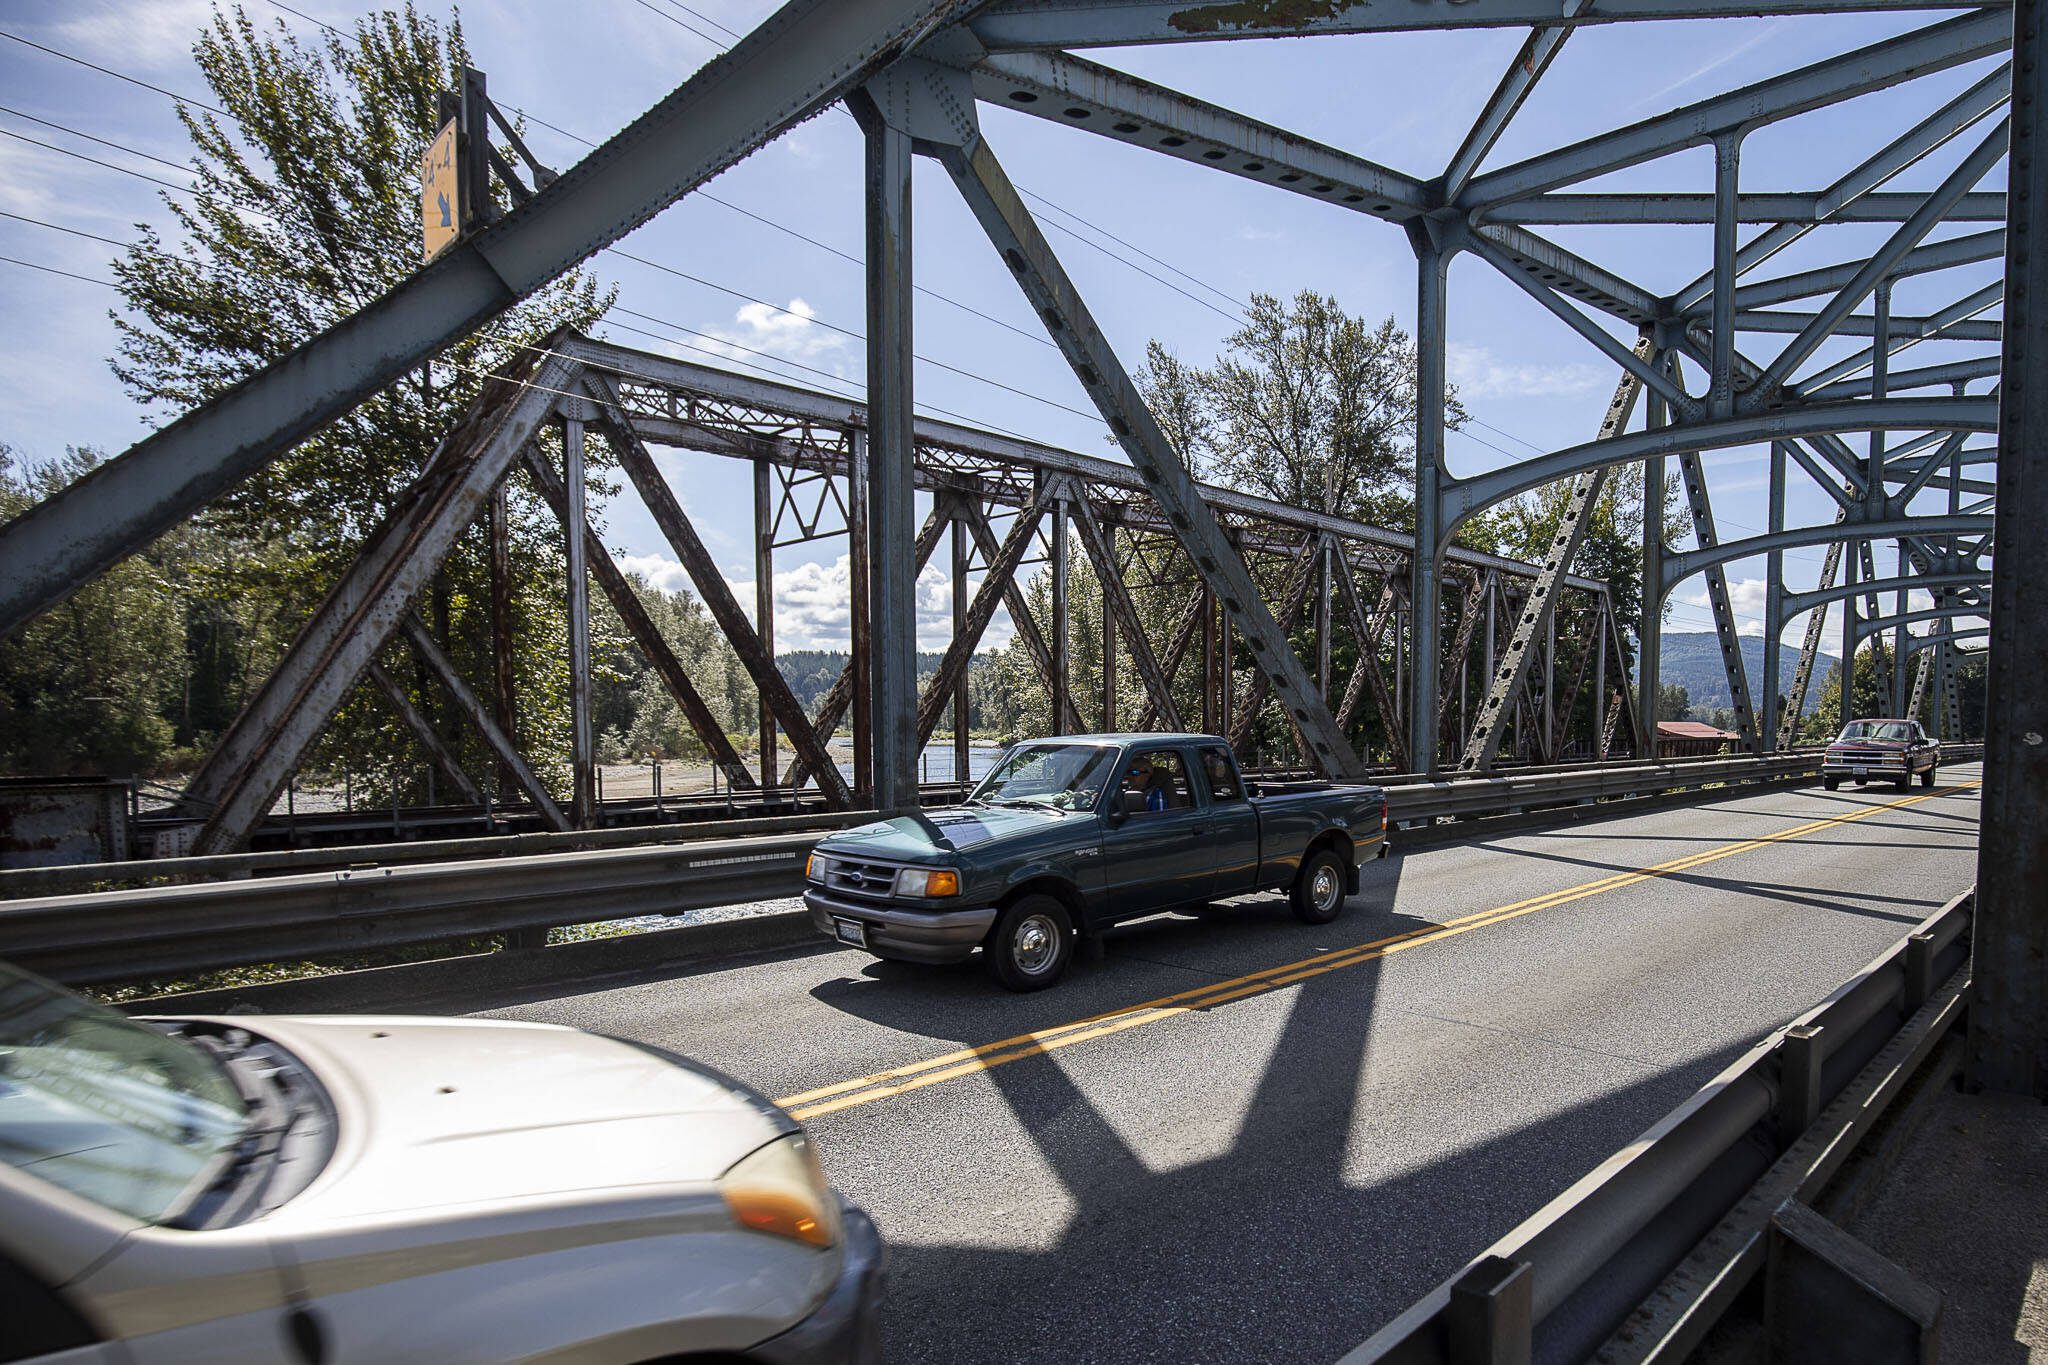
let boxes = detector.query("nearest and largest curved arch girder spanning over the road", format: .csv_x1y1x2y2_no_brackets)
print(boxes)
1444,395,1997,527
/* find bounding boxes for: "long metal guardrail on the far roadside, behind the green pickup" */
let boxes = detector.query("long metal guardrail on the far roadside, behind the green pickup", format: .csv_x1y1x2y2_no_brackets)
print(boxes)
0,753,1960,984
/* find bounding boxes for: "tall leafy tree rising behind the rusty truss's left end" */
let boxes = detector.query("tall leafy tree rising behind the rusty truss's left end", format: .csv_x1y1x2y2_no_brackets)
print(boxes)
96,4,610,802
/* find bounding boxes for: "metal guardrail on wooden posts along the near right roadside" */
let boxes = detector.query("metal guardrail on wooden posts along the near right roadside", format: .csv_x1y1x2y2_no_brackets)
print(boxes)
1341,890,1974,1365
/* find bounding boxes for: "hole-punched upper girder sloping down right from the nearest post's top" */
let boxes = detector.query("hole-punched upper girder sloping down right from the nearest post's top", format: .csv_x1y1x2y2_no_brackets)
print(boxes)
975,53,1430,221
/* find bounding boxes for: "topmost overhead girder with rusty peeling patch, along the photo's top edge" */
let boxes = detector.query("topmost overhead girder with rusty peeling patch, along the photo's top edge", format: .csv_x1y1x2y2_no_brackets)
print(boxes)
967,0,2007,51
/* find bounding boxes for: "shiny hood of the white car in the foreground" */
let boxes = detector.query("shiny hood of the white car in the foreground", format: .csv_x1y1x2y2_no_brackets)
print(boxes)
231,1015,795,1220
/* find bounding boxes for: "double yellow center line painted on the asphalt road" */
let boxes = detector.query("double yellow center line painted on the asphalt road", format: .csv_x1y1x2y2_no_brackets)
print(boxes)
776,782,1978,1119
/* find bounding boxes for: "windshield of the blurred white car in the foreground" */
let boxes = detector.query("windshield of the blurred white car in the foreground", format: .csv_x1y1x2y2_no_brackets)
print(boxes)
0,964,250,1222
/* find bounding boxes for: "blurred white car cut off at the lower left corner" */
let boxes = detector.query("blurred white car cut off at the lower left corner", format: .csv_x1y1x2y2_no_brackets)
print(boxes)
0,964,883,1365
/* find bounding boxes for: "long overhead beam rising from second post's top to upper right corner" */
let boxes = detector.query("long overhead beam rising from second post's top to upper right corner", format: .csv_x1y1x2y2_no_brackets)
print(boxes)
1458,10,2011,209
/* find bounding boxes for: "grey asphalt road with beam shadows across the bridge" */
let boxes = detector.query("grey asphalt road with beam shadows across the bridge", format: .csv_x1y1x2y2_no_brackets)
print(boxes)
461,767,1976,1365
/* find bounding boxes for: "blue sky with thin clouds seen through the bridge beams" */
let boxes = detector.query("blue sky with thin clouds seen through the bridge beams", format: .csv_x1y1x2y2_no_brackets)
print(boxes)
0,0,2003,663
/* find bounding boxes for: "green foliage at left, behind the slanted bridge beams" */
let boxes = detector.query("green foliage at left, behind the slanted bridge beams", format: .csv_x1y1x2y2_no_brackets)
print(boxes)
4,4,621,796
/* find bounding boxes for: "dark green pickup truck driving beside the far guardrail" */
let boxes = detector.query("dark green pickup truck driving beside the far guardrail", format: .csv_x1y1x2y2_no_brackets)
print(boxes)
803,735,1386,990
